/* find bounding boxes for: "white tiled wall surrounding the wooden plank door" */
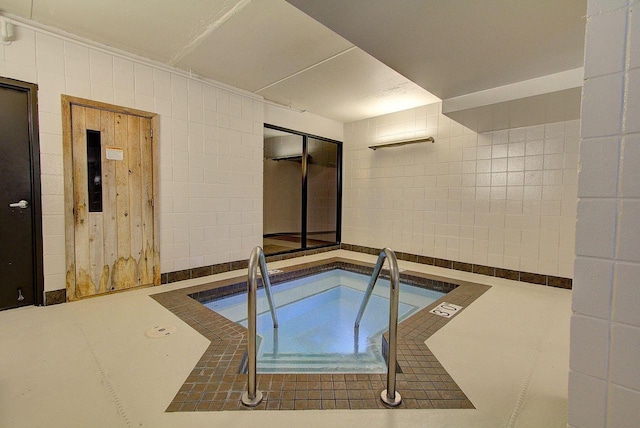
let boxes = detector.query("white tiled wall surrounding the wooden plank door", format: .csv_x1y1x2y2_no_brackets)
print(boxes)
0,24,264,291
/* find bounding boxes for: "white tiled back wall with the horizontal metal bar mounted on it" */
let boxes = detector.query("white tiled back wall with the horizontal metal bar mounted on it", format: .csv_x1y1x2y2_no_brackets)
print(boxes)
343,104,580,277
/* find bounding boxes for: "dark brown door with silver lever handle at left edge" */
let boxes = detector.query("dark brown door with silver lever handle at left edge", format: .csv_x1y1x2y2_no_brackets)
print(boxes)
0,81,41,310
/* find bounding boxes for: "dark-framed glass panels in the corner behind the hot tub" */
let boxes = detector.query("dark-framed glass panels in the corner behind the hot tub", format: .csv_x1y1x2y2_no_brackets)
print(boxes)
263,125,342,255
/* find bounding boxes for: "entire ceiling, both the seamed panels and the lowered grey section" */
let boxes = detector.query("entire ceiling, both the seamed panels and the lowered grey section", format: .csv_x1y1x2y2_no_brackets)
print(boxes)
0,0,586,122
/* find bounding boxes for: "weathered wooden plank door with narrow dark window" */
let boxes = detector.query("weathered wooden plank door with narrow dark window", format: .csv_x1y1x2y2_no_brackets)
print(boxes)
65,95,160,300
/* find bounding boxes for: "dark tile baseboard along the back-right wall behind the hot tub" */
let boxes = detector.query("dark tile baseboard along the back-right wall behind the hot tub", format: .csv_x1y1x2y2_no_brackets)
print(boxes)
340,244,573,290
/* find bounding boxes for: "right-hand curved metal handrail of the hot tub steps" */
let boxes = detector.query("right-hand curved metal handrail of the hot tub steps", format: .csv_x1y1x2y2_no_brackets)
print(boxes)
354,248,402,407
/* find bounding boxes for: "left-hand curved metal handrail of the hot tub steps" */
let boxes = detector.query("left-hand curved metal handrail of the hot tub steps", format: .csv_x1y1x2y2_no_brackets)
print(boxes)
242,247,278,407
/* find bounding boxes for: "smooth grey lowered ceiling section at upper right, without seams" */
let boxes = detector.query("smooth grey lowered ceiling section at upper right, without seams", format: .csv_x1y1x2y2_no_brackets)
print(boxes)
287,0,586,99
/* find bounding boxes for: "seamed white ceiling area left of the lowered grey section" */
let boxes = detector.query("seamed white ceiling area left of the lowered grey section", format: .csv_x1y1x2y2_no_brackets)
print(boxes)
0,0,438,122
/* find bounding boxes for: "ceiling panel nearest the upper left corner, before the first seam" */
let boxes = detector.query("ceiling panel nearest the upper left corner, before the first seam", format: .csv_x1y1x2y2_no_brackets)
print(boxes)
26,0,239,63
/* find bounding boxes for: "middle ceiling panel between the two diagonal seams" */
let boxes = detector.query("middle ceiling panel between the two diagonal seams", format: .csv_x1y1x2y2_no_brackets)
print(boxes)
176,1,352,91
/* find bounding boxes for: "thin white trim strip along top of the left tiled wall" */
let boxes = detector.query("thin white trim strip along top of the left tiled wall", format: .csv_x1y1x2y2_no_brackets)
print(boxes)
0,11,264,101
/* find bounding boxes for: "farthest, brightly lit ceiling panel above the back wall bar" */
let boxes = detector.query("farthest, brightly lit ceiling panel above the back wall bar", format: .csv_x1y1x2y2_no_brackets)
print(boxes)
259,49,438,122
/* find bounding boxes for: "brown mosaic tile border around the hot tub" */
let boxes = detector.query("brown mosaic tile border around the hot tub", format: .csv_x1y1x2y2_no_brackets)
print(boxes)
151,258,490,412
